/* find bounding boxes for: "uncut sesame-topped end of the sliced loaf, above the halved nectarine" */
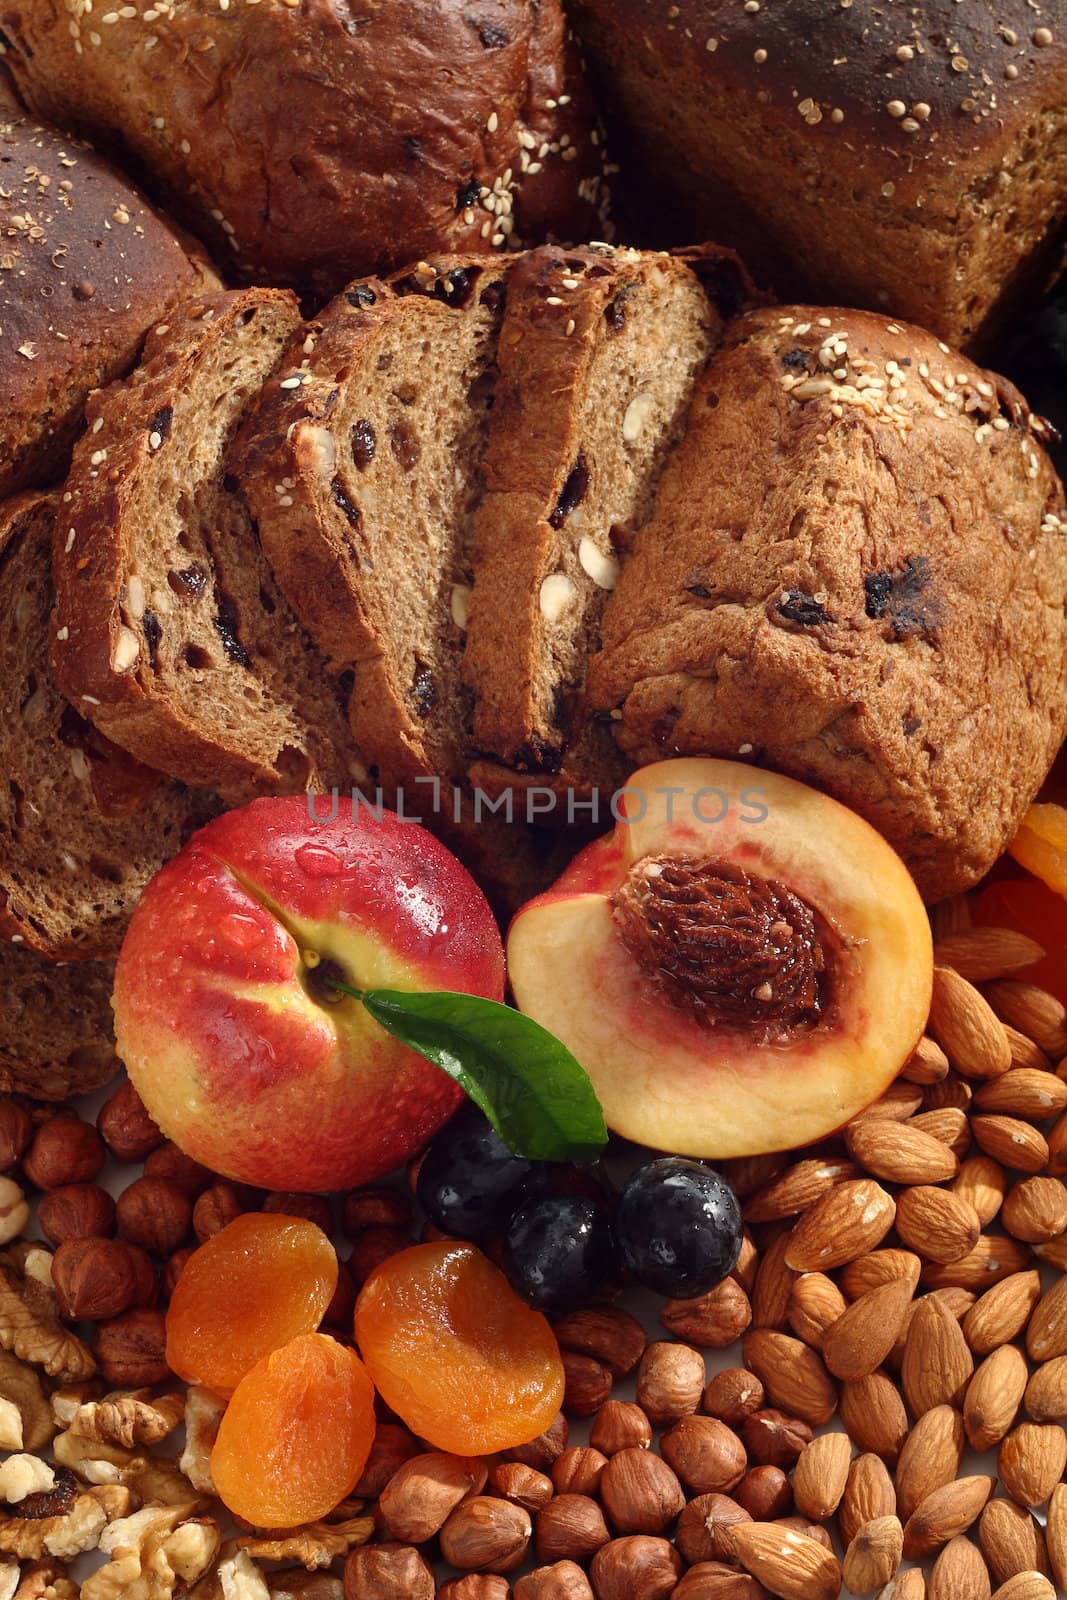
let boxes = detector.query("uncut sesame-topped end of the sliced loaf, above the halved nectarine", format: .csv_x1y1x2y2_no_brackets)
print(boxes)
589,307,1067,901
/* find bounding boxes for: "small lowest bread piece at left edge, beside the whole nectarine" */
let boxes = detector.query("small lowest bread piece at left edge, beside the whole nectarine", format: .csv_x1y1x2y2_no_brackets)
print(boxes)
0,944,118,1101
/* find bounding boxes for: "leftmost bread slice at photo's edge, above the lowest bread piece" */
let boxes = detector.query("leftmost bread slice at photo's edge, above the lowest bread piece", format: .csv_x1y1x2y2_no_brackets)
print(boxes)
0,494,216,958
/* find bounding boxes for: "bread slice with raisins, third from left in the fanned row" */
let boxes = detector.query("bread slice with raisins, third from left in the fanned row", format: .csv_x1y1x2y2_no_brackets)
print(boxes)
232,258,506,790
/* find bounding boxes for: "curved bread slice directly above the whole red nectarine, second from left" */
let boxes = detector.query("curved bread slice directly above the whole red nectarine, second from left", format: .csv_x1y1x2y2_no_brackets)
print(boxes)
53,290,362,800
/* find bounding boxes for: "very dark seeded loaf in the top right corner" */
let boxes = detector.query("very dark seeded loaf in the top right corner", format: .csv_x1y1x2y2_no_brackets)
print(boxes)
571,0,1067,344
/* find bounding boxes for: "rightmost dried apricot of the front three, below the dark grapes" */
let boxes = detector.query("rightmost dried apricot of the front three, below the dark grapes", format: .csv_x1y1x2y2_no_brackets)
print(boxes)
355,1240,563,1456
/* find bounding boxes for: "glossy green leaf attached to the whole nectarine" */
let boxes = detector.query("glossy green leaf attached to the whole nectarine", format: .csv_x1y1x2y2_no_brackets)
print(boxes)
338,984,608,1162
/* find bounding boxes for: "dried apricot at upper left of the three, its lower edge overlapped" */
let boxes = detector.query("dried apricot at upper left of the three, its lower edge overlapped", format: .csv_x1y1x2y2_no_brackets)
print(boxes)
166,1211,338,1394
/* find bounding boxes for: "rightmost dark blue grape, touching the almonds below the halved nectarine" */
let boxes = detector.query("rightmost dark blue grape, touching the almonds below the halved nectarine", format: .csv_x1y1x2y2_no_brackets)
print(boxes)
616,1155,741,1299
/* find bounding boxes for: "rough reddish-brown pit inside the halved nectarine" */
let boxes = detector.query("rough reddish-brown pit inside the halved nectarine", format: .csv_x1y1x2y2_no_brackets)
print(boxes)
611,856,829,1038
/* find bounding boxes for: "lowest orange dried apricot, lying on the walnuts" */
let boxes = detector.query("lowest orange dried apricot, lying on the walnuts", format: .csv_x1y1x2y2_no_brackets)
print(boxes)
211,1333,374,1528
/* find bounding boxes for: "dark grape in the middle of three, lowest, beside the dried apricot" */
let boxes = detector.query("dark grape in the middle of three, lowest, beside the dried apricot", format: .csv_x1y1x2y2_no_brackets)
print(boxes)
504,1195,616,1310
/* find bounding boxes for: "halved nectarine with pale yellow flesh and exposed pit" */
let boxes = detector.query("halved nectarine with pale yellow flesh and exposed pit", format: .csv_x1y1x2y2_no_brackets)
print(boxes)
507,760,933,1157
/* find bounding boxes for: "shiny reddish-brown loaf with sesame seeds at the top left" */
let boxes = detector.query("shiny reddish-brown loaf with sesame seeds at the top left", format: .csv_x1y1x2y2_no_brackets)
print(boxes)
0,0,605,298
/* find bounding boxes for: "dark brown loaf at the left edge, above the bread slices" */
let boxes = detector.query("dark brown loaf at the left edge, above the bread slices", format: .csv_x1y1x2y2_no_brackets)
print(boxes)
0,102,216,498
